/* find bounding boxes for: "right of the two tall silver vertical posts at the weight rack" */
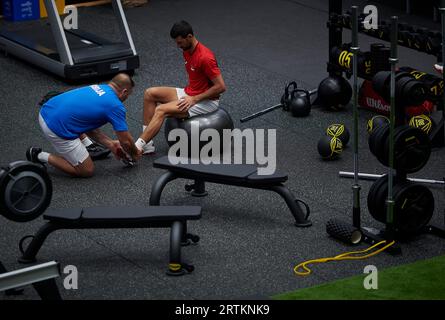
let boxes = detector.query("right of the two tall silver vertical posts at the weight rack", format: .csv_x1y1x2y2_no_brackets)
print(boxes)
386,16,399,241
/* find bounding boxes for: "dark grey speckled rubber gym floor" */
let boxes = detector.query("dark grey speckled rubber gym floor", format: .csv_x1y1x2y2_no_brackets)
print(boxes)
0,0,445,299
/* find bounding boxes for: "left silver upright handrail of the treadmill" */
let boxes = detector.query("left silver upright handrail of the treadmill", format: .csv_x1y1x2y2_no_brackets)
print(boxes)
44,0,74,66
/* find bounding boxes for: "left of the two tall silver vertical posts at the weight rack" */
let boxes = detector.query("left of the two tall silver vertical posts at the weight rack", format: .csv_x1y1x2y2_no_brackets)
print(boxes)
351,6,360,228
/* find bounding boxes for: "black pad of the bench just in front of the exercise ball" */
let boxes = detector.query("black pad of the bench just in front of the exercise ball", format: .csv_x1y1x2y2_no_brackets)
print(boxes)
153,156,287,185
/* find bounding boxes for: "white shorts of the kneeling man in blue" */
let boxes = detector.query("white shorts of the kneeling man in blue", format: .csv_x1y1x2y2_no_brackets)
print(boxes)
39,113,89,166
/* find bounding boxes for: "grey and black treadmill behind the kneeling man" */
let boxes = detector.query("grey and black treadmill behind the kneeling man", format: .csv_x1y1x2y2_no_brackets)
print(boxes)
0,0,139,80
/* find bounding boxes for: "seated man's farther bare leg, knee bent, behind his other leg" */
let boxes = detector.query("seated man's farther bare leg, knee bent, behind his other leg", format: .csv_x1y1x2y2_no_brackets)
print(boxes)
143,87,178,126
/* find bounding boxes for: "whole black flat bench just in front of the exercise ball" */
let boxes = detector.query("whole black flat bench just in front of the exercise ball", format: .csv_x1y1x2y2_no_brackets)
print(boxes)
150,156,312,227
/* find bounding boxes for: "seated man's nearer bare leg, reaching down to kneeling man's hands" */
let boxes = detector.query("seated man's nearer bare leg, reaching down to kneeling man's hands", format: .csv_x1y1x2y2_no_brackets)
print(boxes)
140,100,188,142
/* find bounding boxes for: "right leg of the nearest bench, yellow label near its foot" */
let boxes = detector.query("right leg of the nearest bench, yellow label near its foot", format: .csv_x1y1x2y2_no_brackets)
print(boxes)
167,221,194,276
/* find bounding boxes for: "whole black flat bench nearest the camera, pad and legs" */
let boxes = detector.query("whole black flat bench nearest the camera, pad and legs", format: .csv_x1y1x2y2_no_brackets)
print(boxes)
19,206,201,276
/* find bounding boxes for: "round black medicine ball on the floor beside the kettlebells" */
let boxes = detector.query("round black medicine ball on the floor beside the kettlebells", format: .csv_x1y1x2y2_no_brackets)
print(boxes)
317,76,352,110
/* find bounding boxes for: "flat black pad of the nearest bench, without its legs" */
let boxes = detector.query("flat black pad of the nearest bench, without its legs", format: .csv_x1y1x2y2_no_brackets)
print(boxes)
43,206,201,222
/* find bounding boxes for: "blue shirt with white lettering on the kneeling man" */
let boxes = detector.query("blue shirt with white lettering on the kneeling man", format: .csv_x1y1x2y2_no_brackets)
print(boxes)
40,84,128,140
